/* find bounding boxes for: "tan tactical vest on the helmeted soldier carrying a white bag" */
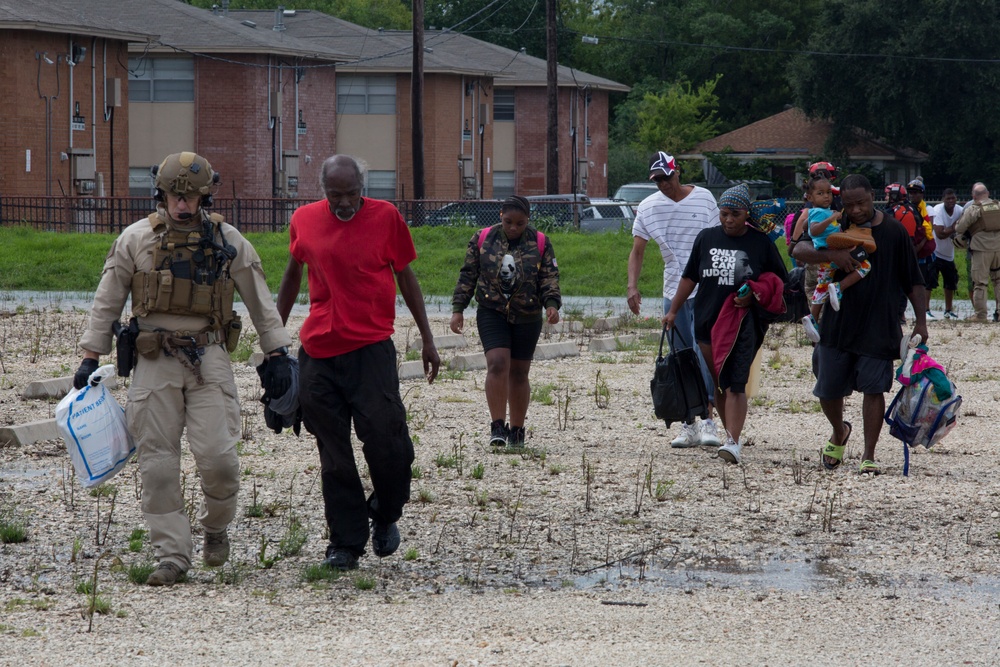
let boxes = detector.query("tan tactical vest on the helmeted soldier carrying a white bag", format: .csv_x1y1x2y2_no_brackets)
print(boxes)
132,213,235,331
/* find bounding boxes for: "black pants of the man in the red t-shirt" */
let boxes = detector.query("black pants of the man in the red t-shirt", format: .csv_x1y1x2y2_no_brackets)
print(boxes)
299,340,413,556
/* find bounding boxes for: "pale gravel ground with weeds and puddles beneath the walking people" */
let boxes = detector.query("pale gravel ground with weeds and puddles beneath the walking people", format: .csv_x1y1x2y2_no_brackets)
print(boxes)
0,304,1000,665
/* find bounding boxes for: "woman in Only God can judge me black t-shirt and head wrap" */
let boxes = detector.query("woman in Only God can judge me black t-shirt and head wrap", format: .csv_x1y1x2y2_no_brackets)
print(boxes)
663,184,786,463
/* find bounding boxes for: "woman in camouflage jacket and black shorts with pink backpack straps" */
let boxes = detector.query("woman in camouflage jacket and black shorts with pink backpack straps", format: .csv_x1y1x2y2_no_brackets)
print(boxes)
451,195,562,448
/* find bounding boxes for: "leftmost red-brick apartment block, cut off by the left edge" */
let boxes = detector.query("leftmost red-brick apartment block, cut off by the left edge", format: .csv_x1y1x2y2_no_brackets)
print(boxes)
0,3,152,195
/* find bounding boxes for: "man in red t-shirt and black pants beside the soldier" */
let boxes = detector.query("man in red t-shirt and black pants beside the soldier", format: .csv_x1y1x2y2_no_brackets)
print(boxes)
277,155,441,570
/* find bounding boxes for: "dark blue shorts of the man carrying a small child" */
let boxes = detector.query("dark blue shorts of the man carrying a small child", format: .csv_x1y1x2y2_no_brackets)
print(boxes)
813,345,893,400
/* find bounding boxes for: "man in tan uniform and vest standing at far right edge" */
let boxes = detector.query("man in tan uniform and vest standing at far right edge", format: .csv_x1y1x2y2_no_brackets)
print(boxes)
954,183,1000,322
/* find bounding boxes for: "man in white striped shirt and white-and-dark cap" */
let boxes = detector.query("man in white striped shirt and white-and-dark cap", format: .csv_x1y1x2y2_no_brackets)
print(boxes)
627,151,721,448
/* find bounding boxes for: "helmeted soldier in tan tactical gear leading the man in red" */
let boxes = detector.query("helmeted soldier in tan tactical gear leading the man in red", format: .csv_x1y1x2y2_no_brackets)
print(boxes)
73,152,292,586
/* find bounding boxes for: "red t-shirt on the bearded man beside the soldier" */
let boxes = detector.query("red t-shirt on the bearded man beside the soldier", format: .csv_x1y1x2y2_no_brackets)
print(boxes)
289,198,417,359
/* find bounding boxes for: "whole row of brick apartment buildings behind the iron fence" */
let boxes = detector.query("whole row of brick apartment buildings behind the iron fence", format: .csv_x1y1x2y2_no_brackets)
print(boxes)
0,0,627,204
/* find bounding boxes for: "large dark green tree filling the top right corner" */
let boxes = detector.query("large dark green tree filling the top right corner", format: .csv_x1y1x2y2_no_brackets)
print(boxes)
790,0,1000,184
